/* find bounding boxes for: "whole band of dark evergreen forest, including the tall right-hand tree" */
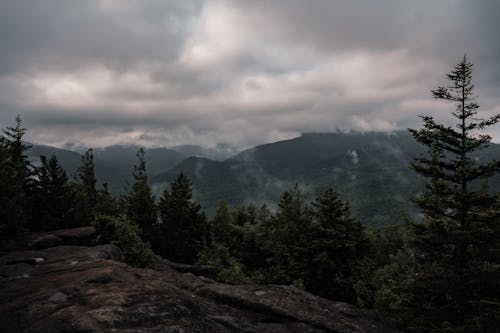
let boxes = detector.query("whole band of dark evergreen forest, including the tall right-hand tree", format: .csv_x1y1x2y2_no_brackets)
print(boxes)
0,56,500,332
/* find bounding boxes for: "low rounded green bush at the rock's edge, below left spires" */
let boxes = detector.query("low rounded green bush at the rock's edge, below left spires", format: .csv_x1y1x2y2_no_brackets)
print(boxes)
93,215,153,267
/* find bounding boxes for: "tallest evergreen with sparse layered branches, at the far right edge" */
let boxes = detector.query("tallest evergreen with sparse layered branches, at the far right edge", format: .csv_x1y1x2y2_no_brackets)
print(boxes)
379,56,500,332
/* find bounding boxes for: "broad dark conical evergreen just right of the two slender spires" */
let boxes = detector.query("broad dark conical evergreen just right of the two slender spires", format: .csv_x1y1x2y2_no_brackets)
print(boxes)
153,173,208,263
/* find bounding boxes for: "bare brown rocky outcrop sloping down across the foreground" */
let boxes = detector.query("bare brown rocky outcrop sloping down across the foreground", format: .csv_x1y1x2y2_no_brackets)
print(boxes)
0,228,398,333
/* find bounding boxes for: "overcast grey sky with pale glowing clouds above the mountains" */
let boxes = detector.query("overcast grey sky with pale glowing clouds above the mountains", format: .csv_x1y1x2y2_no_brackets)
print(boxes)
0,0,500,147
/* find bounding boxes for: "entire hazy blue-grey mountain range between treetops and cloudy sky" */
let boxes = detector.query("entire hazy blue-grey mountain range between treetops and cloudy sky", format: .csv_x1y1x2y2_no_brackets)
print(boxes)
30,132,500,225
